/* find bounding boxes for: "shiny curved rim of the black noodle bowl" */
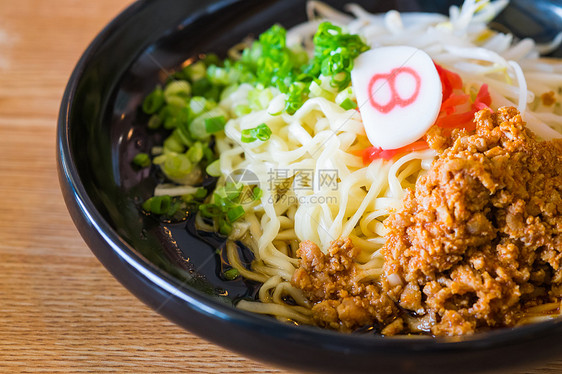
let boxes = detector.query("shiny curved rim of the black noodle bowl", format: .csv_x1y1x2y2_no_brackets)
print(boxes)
57,0,562,362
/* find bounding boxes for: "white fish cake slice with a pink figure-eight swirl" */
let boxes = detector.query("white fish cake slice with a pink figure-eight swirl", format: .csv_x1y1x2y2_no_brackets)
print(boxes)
351,46,443,149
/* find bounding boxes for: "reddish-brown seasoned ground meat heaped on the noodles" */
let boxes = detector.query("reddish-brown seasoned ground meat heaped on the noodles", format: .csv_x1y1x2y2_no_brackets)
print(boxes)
293,107,562,335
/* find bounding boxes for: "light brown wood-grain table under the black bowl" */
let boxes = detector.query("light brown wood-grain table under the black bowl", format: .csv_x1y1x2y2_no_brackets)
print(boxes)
0,0,562,374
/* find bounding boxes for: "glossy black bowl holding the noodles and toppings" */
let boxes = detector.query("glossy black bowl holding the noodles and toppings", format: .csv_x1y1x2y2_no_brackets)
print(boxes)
57,0,562,373
